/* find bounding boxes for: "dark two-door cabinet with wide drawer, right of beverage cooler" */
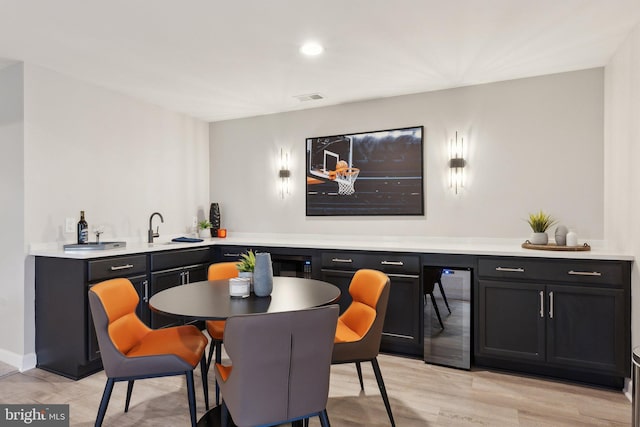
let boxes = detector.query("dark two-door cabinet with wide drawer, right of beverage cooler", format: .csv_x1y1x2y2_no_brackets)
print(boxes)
475,257,631,388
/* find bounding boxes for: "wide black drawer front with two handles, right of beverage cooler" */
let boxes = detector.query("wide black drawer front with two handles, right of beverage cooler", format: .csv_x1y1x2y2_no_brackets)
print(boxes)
478,257,625,286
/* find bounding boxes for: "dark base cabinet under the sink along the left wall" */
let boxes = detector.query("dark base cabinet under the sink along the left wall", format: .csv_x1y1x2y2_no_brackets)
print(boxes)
35,248,210,379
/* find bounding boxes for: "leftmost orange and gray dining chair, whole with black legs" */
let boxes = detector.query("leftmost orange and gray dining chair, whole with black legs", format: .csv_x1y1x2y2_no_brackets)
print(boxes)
89,279,209,426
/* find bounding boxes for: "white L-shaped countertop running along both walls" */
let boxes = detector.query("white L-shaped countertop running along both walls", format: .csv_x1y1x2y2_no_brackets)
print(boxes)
29,232,634,261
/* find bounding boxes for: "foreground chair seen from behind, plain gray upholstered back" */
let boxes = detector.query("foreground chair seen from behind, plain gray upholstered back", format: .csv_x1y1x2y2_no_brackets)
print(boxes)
215,305,339,427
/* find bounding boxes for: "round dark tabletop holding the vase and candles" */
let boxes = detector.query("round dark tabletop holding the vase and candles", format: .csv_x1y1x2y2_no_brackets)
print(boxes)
149,276,340,320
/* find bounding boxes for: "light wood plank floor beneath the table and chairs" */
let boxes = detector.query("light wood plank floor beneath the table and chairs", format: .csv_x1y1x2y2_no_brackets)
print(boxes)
0,355,631,427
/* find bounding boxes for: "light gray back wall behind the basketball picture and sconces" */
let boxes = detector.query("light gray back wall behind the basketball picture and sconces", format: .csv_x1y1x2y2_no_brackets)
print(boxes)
210,68,604,240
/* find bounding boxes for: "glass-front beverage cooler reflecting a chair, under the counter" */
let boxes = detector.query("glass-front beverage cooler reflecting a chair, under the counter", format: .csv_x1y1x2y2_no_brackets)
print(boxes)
423,267,471,369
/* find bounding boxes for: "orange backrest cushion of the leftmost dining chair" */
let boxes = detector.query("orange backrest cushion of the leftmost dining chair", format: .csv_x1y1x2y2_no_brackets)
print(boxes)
91,279,151,355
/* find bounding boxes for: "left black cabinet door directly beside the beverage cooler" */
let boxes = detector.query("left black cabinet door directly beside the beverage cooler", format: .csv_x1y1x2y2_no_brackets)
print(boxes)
476,280,545,362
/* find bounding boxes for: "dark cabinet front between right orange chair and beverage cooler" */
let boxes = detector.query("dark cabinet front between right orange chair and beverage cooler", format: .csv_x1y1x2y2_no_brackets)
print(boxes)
382,274,422,344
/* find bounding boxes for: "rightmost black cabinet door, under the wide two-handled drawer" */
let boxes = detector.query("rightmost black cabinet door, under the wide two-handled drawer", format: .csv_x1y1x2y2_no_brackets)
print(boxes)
547,285,625,375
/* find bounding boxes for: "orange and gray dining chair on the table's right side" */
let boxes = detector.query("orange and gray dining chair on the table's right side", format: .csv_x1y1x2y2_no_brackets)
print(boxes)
331,269,396,427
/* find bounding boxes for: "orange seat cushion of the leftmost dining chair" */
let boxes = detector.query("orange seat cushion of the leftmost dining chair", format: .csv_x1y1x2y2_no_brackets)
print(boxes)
126,325,207,366
